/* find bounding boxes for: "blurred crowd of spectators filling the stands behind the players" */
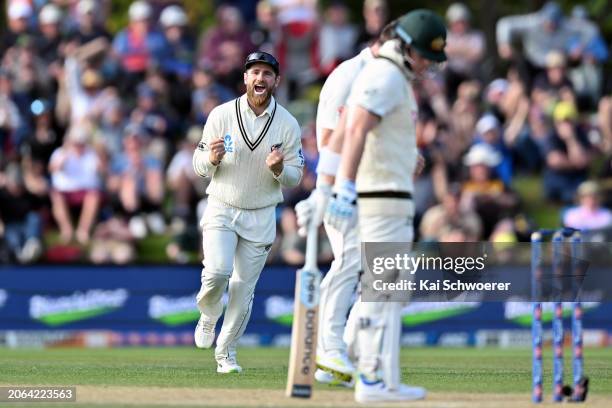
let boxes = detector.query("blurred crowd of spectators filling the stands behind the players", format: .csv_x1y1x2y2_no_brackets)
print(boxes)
0,0,612,265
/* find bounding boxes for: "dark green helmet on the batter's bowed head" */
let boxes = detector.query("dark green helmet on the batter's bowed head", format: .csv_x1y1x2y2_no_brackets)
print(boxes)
395,9,446,62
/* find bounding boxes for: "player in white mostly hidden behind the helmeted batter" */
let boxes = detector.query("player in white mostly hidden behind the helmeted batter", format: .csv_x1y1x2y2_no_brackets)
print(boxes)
295,24,393,386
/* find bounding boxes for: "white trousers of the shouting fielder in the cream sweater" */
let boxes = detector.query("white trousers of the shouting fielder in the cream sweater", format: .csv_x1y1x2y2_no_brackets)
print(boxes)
196,197,276,360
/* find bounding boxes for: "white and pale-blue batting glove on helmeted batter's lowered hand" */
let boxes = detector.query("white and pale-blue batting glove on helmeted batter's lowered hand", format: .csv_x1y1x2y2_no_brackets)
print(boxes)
324,180,357,234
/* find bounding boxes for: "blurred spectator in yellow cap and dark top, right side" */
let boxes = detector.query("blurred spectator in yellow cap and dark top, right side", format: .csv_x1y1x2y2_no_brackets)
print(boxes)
543,101,592,204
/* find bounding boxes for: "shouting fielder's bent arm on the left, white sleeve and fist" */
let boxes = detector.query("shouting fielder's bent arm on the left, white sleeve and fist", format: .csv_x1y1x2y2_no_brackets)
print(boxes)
192,109,225,177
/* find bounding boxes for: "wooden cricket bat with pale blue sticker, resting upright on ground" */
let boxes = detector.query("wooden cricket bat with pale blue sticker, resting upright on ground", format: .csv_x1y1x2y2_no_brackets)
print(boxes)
286,223,321,398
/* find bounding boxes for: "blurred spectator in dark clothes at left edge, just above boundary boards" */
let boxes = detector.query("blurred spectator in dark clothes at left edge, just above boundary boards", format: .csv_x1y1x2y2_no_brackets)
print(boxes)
0,163,42,263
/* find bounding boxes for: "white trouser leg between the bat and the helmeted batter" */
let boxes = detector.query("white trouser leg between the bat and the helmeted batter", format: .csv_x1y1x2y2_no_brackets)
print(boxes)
317,220,361,355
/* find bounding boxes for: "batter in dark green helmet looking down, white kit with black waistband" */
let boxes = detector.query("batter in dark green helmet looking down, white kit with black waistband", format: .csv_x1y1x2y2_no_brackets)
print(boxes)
326,10,446,403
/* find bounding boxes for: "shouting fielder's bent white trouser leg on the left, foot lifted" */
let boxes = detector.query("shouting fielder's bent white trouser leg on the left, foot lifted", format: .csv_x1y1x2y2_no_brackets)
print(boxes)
196,226,238,321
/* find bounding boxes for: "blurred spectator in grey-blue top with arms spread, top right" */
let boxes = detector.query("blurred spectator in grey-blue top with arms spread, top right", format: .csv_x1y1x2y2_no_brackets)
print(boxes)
496,1,592,87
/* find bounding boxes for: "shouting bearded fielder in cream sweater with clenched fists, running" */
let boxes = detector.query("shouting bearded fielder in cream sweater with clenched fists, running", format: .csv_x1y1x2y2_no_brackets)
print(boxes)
193,51,304,373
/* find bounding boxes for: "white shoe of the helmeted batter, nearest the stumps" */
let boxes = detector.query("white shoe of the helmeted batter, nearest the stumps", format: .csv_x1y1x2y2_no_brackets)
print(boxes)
355,375,427,403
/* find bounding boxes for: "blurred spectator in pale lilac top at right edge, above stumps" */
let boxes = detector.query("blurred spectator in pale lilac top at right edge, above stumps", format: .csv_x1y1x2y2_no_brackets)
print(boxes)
563,181,612,231
